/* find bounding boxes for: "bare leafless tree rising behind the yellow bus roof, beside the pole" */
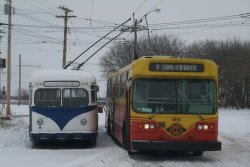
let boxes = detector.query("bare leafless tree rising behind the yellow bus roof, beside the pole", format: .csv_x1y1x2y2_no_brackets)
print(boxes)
100,35,184,73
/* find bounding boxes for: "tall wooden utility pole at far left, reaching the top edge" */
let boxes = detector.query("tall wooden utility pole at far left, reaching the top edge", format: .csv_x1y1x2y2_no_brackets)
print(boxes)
6,0,12,117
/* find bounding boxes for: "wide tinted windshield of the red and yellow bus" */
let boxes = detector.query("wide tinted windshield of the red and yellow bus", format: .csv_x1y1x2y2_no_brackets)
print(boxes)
133,79,217,114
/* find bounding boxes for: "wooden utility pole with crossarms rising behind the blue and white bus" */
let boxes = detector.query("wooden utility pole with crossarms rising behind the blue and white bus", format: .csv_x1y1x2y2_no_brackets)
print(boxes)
56,6,76,67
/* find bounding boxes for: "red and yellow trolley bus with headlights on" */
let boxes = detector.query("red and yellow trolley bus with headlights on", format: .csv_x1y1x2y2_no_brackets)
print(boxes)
106,56,221,155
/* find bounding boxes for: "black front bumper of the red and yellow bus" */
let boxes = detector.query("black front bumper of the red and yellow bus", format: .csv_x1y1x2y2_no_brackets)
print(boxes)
132,140,221,152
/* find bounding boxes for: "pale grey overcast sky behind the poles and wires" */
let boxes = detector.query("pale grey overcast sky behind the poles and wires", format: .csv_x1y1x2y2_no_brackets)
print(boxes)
0,0,250,96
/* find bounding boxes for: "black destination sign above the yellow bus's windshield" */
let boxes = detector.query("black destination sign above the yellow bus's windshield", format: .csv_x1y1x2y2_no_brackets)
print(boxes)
149,63,204,72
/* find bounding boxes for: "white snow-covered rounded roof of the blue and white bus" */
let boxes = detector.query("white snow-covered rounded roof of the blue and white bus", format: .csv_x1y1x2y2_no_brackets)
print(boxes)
31,69,96,82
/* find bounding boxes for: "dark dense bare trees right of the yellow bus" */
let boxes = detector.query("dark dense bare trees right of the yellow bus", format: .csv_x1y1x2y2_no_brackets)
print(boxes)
186,38,250,108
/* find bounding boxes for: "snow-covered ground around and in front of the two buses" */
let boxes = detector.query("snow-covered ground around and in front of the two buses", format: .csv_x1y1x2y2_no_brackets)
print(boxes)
0,106,250,167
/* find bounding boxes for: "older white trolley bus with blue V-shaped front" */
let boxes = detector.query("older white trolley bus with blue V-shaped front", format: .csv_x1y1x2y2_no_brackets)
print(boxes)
29,70,98,144
